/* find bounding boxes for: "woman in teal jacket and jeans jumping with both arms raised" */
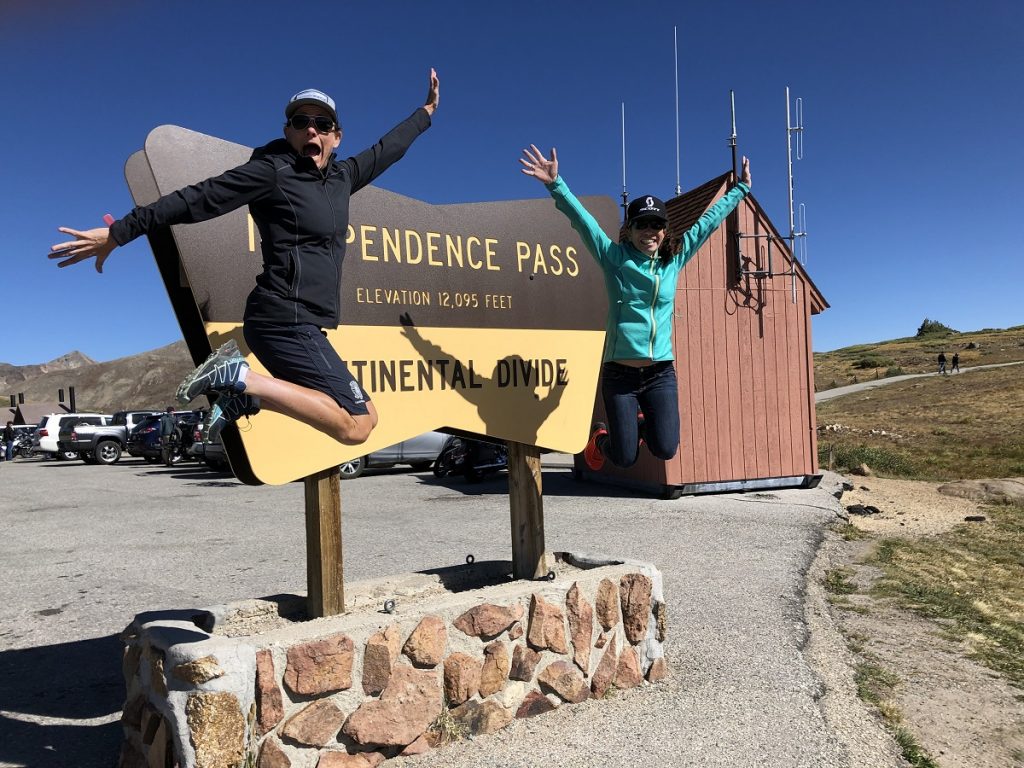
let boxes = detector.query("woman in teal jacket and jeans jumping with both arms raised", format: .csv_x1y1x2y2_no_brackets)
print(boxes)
519,144,751,471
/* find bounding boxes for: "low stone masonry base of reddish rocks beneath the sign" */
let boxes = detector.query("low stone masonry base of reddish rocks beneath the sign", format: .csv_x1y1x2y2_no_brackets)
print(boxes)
120,553,667,768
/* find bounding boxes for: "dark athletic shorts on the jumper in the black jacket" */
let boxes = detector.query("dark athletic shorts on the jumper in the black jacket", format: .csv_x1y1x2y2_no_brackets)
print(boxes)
242,321,370,416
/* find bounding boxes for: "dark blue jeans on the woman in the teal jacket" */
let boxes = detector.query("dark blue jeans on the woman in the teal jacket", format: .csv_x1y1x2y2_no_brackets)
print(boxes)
598,360,679,467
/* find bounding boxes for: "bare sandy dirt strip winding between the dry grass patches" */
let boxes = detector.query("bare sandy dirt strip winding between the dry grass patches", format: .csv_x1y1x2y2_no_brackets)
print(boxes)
825,476,1024,768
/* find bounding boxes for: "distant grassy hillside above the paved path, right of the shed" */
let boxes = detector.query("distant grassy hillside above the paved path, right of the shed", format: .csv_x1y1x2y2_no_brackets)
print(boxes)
814,326,1024,391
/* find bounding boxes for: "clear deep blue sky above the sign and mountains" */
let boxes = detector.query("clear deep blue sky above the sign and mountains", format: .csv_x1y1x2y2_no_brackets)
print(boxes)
0,0,1024,365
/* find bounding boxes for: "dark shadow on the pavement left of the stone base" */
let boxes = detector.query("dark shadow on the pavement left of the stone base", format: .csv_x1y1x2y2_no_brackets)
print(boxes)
0,635,125,768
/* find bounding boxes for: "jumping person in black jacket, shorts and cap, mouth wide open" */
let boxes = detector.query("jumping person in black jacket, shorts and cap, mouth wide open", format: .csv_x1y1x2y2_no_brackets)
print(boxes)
49,72,438,445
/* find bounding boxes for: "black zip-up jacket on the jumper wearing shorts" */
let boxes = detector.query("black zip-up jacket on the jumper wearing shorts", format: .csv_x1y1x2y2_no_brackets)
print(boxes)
111,108,430,328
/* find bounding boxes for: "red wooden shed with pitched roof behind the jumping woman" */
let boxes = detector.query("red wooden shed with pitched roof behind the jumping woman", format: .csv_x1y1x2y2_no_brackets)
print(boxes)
575,173,828,498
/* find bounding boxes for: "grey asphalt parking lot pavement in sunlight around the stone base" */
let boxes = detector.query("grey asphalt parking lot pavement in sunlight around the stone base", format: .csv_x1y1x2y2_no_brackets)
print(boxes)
0,456,891,768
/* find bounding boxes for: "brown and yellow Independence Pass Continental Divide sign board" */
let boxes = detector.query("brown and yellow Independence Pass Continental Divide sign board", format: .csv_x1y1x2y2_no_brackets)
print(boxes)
125,126,618,483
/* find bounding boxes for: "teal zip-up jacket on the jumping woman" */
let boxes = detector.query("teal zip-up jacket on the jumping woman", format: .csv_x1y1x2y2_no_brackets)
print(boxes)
545,176,751,361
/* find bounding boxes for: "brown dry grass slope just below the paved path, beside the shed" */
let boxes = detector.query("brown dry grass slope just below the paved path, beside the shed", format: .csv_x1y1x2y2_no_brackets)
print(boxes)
817,364,1024,480
